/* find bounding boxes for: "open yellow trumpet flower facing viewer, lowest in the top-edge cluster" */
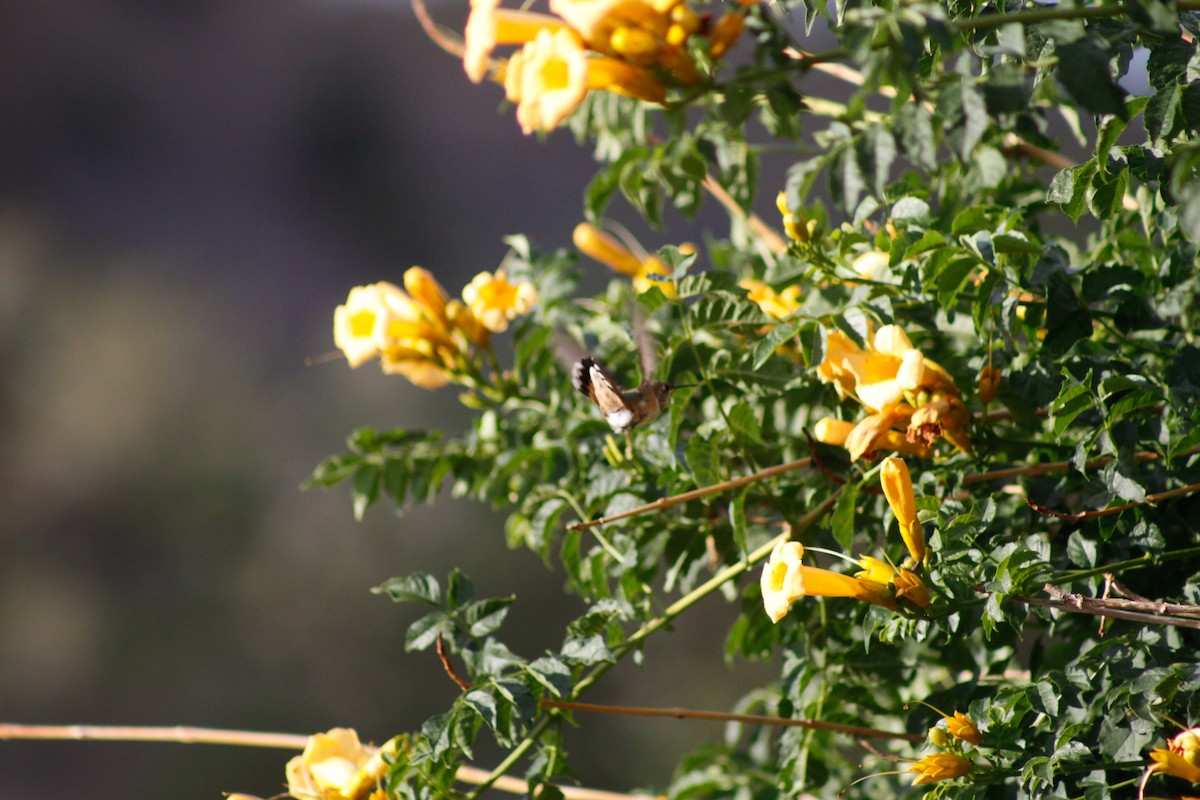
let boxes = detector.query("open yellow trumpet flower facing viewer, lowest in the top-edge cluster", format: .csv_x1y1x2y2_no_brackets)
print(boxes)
504,28,666,134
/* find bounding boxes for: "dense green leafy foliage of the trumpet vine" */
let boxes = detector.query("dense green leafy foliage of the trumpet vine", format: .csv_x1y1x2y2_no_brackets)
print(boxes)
307,0,1200,800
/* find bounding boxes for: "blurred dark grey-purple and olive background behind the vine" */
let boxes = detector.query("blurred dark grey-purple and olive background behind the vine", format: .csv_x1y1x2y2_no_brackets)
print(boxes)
0,0,796,800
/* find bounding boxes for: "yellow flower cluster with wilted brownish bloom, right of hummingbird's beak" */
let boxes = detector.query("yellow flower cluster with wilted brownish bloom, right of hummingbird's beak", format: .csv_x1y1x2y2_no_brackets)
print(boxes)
815,325,971,459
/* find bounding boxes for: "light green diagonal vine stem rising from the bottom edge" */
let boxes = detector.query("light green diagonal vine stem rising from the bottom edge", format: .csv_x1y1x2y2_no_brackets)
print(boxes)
467,489,840,800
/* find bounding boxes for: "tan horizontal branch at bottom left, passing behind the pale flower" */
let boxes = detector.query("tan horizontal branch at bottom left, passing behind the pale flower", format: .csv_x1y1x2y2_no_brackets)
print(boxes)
0,722,656,800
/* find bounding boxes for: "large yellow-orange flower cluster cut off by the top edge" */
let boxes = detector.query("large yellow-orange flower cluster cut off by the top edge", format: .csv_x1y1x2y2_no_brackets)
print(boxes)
463,0,744,134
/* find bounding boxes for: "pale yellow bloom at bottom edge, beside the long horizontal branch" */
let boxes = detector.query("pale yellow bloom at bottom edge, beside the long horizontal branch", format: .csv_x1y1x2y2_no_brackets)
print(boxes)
286,728,396,800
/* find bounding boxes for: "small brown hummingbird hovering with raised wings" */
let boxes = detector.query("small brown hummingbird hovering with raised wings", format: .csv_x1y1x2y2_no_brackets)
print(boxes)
556,314,694,433
